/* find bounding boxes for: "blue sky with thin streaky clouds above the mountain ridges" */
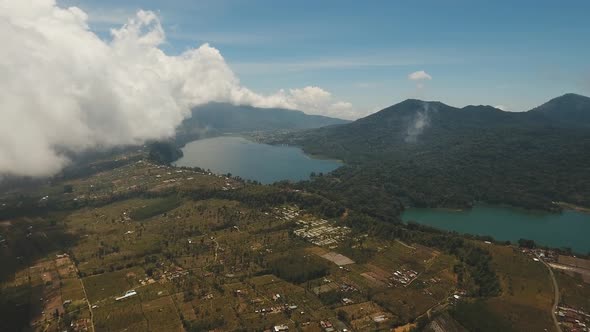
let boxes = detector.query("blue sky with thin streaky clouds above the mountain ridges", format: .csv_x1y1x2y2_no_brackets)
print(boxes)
58,0,590,112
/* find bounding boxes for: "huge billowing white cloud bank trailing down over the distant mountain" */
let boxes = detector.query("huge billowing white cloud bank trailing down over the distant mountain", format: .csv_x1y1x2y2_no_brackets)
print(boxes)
0,0,352,176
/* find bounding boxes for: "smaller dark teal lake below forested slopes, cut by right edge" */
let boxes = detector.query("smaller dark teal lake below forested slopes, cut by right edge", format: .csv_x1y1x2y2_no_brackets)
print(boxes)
402,206,590,254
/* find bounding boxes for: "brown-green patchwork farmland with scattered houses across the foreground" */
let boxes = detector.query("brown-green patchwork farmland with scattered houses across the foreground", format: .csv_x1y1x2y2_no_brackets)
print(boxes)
0,154,587,331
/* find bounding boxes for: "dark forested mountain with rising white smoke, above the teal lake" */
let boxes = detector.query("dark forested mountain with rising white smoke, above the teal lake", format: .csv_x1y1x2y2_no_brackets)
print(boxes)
275,94,590,219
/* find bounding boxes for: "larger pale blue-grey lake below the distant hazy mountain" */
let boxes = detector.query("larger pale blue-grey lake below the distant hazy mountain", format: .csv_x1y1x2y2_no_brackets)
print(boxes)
175,136,342,183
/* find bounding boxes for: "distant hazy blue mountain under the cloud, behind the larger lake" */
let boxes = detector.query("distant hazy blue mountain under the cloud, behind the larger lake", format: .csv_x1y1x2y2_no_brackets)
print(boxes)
177,103,350,142
